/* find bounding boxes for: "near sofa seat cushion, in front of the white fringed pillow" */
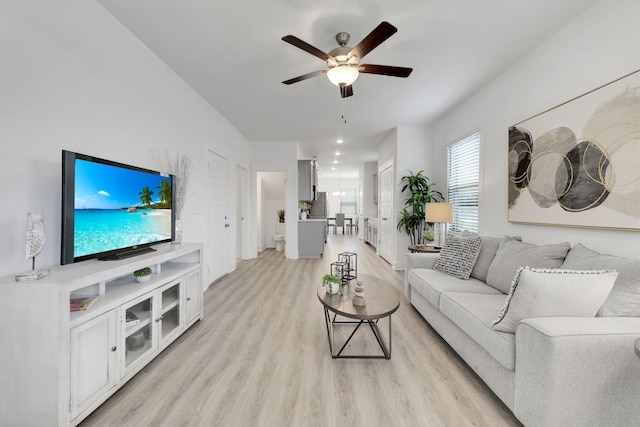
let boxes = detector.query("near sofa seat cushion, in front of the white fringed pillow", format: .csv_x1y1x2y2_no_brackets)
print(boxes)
440,292,516,370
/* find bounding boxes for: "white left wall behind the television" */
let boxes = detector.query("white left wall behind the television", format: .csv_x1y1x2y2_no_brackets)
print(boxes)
0,0,249,275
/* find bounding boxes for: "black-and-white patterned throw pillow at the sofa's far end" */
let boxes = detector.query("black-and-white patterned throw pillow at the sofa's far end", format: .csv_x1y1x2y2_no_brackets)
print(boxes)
433,234,482,280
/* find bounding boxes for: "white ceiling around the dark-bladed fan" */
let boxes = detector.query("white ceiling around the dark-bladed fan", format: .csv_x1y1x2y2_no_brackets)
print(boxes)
98,0,596,176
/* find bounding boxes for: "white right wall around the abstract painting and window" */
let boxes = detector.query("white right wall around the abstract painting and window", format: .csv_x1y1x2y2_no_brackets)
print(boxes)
434,0,640,258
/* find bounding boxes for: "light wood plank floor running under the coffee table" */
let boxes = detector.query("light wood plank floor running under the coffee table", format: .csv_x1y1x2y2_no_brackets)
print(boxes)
81,235,519,427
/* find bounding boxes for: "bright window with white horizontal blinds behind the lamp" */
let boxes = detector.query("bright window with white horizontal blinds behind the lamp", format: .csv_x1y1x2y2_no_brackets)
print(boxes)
447,132,480,233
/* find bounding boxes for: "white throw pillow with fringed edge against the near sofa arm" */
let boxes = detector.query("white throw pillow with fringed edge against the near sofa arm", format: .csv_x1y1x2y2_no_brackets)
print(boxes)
493,267,618,333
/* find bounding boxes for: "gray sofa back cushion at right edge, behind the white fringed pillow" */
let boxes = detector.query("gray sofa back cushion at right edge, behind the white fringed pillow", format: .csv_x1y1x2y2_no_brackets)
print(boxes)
562,244,640,317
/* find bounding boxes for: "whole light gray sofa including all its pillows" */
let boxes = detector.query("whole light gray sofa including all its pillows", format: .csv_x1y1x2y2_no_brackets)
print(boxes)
405,235,640,427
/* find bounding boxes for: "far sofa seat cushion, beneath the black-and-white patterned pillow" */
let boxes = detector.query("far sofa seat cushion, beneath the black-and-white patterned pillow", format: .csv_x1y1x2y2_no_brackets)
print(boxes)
407,268,505,310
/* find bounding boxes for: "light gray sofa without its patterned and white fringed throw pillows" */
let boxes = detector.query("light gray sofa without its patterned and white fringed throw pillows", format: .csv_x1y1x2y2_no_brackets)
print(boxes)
405,236,640,427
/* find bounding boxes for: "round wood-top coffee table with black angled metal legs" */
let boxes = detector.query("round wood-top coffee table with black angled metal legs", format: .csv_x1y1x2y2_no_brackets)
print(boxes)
318,274,400,359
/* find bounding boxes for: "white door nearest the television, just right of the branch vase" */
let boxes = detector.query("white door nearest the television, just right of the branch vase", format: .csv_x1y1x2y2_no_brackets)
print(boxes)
205,151,230,286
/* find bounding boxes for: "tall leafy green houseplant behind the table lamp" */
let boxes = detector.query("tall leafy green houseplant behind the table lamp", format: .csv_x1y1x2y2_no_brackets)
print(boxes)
398,171,444,246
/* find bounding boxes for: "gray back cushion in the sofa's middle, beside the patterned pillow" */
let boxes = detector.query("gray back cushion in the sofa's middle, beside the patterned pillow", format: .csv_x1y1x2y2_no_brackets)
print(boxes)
487,240,571,294
